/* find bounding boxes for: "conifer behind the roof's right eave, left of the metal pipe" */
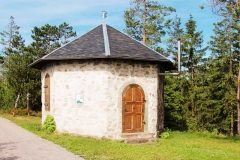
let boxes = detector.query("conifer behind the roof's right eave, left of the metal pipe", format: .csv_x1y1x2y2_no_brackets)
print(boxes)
164,16,187,130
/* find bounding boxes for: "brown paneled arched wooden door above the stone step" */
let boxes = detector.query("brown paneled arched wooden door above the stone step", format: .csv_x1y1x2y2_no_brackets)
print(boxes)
122,84,145,133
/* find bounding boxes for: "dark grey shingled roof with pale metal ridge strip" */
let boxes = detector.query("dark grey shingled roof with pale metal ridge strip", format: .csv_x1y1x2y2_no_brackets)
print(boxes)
29,23,173,70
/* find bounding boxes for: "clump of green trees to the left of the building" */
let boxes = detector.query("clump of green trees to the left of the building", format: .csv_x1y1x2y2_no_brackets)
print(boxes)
0,17,76,110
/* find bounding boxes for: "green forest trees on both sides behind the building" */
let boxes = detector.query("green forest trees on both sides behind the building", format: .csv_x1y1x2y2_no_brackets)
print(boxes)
0,0,240,135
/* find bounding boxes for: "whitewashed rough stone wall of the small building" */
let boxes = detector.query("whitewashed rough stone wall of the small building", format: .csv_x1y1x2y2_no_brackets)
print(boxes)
42,60,163,139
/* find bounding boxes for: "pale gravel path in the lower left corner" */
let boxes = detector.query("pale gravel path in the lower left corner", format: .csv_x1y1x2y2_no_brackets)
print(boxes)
0,118,83,160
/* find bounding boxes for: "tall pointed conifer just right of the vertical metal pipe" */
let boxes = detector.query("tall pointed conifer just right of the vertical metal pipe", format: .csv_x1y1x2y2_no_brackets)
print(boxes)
181,15,207,129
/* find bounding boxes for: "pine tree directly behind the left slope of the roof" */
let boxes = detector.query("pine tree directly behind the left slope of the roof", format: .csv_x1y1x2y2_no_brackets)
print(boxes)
28,22,76,110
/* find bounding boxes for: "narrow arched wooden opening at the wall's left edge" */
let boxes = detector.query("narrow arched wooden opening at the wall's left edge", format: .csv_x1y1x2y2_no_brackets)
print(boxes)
44,74,50,111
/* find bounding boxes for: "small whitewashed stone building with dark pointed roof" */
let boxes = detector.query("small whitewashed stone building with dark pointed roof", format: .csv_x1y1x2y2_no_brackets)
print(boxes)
30,23,173,140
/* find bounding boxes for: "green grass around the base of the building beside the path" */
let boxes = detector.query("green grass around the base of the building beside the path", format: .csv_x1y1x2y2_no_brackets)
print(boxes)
1,115,240,160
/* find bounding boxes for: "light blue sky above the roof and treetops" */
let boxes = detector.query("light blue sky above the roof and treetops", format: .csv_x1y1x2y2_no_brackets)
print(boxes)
0,0,219,48
